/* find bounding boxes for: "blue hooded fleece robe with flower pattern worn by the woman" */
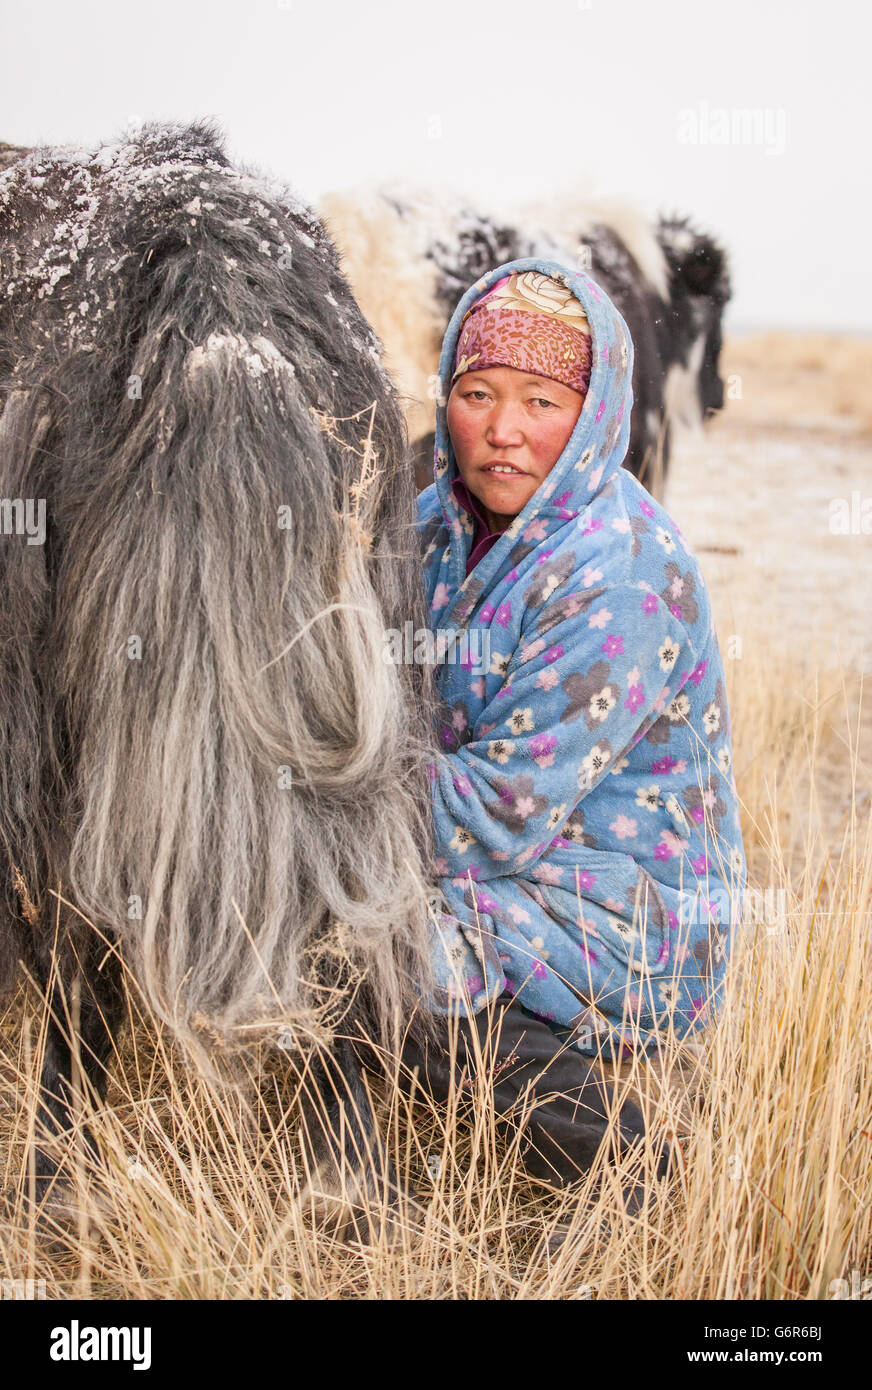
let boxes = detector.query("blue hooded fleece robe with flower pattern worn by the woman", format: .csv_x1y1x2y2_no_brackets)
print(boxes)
419,259,745,1052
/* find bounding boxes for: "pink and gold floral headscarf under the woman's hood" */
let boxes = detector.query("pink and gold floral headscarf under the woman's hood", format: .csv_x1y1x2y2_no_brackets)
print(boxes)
452,270,591,396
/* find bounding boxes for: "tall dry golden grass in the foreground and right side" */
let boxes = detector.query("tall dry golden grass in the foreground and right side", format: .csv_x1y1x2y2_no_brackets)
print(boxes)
0,603,872,1300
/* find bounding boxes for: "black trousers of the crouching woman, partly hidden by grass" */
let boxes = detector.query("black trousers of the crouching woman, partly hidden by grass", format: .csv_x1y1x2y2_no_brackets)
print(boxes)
402,994,670,1189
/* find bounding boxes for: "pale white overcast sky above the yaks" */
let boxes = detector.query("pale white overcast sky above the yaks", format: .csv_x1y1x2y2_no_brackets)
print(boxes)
0,0,872,332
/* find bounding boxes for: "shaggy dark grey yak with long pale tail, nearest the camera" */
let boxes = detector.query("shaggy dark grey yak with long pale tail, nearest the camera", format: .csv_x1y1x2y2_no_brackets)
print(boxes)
0,122,431,1206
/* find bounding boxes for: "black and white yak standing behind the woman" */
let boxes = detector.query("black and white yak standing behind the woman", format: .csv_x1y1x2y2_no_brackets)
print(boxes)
320,185,730,493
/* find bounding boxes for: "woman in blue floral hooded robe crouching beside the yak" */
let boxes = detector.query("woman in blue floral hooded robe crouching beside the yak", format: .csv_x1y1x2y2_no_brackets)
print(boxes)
406,259,745,1176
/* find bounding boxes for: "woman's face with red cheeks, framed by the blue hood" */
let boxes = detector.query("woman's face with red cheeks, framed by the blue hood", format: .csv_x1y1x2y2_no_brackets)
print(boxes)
446,367,584,531
